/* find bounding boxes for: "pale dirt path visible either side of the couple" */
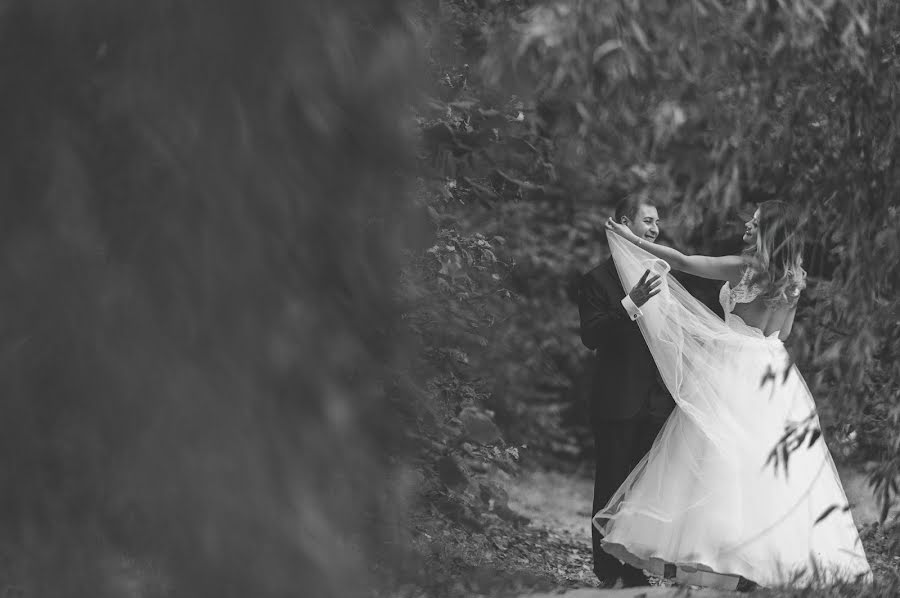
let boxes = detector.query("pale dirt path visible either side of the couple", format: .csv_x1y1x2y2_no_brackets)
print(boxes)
497,468,892,598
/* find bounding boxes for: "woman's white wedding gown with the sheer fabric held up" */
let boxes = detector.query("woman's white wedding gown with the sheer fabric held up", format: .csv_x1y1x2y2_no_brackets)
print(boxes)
594,234,871,589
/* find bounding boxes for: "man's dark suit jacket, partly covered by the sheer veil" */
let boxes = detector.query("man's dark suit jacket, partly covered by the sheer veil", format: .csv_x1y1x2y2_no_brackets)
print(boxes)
578,258,675,422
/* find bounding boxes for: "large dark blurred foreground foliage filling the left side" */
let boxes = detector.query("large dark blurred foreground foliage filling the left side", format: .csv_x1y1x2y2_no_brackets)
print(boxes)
0,0,415,598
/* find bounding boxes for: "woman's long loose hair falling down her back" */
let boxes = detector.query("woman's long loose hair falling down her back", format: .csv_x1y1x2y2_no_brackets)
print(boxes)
747,200,806,305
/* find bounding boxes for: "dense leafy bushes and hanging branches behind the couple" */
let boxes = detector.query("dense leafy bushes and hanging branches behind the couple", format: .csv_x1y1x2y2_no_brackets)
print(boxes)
402,0,900,568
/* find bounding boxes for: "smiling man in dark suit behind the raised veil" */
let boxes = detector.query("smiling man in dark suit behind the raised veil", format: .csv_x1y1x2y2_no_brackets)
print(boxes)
578,195,674,587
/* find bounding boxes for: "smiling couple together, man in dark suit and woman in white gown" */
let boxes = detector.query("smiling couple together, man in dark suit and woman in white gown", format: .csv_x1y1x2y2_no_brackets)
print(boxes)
579,195,872,590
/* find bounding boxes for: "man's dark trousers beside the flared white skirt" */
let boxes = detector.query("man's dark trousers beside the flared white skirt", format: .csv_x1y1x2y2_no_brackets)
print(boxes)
591,414,666,582
